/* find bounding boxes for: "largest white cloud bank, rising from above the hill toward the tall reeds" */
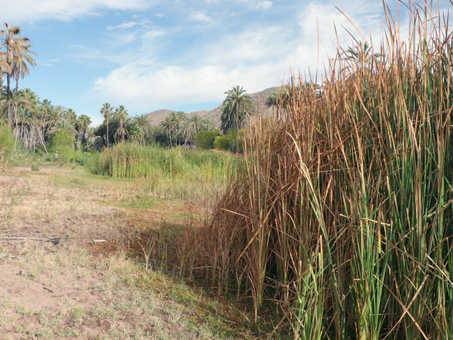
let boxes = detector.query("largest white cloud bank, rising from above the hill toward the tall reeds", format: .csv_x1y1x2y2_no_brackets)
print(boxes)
91,0,392,112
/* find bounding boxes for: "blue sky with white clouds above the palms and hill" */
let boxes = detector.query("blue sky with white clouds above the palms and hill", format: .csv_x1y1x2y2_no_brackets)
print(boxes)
0,0,444,126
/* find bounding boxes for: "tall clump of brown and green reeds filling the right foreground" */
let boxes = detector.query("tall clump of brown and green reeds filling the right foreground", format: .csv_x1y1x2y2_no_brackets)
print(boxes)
188,4,453,340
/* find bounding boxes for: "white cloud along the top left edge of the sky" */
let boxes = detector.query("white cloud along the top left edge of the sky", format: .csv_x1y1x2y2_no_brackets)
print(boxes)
1,0,153,23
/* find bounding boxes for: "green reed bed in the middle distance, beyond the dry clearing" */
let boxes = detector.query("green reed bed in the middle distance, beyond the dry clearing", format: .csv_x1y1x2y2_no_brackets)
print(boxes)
90,143,237,198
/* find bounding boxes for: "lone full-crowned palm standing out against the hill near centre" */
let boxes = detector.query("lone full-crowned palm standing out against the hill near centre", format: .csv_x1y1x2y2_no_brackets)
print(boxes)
220,85,253,133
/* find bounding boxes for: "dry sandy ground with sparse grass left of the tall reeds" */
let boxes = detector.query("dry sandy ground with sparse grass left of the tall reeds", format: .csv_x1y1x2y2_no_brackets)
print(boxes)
0,168,247,339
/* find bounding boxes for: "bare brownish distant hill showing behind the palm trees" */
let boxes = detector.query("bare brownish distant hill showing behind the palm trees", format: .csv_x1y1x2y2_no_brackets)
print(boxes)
146,86,279,125
